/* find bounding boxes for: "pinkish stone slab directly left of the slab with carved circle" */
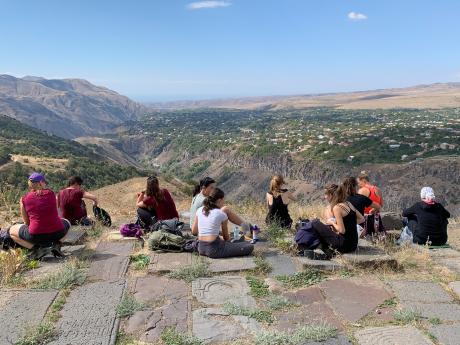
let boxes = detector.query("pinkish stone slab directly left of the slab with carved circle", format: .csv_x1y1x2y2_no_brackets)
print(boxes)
133,275,190,303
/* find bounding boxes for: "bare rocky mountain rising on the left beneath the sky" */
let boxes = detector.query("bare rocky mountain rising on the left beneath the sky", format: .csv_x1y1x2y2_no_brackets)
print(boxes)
0,75,146,138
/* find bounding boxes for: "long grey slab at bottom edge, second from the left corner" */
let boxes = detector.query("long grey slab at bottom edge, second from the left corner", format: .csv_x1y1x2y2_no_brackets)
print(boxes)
49,280,125,345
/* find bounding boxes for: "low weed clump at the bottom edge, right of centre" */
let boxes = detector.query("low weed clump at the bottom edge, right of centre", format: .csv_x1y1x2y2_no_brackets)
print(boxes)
255,324,337,345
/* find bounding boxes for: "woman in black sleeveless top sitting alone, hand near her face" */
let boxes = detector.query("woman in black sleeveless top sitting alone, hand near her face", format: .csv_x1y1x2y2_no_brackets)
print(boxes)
265,175,296,229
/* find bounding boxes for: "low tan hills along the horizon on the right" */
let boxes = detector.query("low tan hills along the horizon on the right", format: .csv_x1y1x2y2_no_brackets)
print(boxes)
150,83,460,110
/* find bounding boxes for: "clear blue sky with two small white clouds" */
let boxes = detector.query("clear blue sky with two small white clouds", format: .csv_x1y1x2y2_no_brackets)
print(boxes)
0,0,460,102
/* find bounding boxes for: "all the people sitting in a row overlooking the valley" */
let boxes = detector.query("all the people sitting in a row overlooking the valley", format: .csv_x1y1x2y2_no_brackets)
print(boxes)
1,172,450,258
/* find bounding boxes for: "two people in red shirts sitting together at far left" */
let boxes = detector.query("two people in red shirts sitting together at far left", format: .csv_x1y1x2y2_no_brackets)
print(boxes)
7,172,97,257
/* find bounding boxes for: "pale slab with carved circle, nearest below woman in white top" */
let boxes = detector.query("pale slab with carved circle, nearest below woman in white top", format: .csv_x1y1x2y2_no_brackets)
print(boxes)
192,276,256,307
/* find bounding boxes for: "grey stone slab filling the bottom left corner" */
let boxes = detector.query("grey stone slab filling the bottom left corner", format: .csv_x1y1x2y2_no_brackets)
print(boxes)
0,289,57,344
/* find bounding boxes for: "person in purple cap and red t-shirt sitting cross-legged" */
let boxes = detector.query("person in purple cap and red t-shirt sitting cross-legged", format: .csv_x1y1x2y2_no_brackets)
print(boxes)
10,172,70,258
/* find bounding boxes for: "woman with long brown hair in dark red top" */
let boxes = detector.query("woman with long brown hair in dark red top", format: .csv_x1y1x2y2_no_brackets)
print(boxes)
137,176,179,228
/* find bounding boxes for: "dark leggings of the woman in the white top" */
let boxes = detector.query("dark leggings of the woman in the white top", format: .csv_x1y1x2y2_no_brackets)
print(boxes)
198,238,254,259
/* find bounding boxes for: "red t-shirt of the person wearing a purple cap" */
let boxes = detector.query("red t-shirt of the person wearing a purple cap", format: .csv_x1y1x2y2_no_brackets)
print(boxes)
22,189,64,235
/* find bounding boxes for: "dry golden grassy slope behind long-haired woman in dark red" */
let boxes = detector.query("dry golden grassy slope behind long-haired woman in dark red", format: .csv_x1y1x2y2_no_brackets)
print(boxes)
93,177,191,225
